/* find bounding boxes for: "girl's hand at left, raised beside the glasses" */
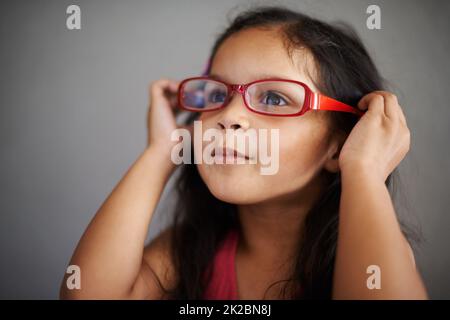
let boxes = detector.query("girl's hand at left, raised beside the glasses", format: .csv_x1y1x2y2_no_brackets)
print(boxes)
147,79,183,154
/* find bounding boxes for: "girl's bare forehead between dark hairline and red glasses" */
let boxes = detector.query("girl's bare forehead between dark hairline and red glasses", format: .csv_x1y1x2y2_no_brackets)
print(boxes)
210,28,317,91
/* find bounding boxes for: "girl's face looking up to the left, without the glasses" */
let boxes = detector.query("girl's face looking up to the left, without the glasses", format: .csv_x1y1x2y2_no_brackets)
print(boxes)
197,28,338,204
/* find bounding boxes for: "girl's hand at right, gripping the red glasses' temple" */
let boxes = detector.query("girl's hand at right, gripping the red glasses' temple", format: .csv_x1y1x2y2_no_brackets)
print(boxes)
339,91,410,182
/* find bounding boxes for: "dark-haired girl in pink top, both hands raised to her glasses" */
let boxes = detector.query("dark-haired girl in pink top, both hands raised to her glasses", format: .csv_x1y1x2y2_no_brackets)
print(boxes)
61,7,427,299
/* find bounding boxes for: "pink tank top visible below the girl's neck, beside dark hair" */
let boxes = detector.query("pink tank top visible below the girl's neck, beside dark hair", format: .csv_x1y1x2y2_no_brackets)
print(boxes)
204,229,238,300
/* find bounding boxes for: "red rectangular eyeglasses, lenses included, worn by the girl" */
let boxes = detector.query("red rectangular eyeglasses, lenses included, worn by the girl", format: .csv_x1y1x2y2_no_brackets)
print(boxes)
178,77,364,117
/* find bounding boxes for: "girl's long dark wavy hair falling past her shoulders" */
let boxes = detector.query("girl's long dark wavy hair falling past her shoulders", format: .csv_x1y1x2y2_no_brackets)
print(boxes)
163,6,414,299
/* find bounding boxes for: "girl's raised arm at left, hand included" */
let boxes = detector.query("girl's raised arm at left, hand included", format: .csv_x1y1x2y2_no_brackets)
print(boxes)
60,80,181,299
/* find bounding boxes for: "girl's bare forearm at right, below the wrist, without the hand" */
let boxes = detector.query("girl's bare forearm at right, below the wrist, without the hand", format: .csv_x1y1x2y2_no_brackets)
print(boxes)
333,164,427,299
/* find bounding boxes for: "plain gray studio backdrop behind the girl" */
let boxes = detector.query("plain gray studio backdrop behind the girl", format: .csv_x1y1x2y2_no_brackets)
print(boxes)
0,0,450,299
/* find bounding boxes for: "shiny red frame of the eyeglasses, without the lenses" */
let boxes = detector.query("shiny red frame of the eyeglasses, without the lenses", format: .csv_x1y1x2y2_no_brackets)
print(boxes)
177,76,365,117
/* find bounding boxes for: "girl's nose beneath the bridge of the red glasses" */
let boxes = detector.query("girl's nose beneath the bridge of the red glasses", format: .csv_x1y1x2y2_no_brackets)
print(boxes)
217,89,250,130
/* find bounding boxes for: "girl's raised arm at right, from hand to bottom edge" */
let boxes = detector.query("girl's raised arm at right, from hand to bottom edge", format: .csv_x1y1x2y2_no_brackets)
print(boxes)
333,92,427,299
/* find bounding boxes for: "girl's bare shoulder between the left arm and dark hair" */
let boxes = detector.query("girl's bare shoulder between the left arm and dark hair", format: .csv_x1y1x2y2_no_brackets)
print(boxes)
133,228,176,299
